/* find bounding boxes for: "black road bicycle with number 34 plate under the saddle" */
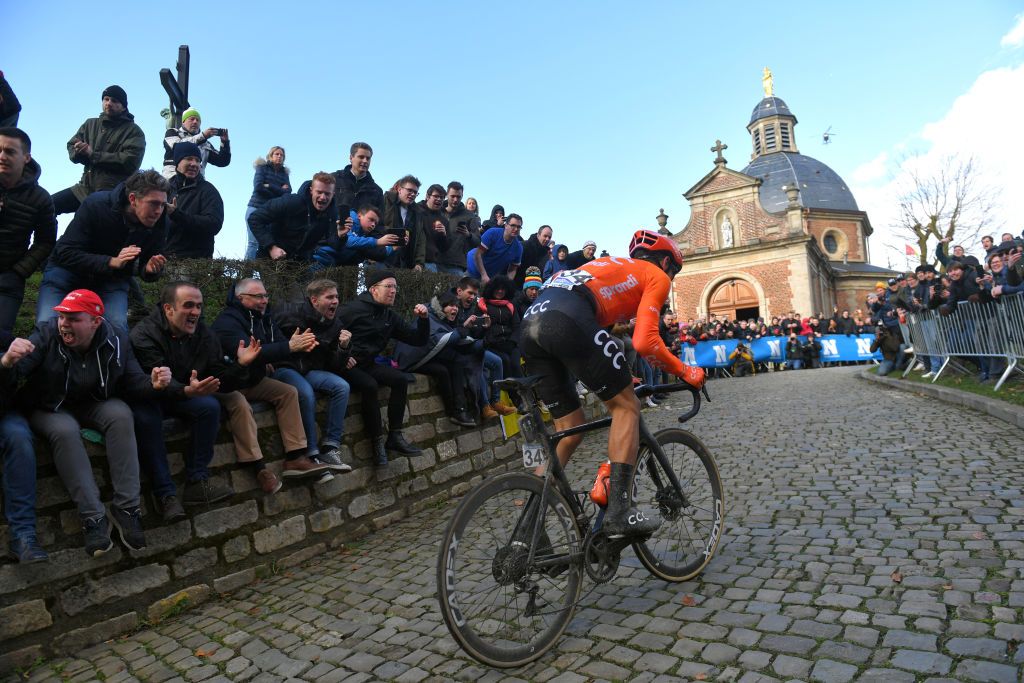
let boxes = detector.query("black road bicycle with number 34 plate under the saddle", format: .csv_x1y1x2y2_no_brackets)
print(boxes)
437,376,725,668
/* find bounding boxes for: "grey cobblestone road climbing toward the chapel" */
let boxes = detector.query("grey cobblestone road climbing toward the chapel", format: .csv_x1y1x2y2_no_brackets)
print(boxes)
12,368,1024,683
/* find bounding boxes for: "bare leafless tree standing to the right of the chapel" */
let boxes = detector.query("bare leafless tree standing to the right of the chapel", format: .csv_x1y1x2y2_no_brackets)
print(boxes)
897,156,996,265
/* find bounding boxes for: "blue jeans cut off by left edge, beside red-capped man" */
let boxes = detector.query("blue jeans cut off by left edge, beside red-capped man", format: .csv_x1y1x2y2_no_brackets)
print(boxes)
0,412,36,540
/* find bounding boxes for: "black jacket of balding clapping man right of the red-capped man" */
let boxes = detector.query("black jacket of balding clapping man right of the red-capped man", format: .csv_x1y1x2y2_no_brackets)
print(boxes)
130,305,249,398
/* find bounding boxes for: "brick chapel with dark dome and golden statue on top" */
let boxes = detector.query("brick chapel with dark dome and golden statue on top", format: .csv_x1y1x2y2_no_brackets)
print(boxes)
659,70,895,319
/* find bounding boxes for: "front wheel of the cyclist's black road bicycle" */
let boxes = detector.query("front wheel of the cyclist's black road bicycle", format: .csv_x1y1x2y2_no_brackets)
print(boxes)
633,429,725,582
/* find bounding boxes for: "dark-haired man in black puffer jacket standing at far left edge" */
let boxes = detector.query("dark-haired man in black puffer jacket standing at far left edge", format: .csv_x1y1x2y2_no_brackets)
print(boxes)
0,128,57,330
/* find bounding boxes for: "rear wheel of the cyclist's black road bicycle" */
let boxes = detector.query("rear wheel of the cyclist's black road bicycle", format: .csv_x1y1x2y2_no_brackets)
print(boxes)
437,472,583,668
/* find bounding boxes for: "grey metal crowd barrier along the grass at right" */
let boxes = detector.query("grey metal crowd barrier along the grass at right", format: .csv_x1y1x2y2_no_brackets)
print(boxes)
900,294,1024,391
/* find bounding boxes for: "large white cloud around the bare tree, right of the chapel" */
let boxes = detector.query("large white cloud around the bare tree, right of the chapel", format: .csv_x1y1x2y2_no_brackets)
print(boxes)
852,63,1024,266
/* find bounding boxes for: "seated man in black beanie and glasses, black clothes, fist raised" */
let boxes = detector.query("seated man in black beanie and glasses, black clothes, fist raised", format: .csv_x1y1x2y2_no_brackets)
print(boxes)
338,269,430,465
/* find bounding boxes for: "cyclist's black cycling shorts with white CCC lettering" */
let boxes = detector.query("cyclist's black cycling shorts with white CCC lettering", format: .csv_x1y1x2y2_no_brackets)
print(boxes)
519,287,633,418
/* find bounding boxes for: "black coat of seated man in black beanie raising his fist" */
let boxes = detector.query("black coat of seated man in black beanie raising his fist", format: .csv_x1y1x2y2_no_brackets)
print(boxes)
337,291,430,366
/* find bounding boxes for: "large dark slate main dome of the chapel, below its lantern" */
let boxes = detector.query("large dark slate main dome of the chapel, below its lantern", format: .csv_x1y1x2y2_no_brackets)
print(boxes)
742,152,859,213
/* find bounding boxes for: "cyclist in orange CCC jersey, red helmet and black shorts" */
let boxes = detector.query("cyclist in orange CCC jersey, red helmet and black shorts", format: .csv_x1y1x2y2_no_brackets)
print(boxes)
520,230,705,538
